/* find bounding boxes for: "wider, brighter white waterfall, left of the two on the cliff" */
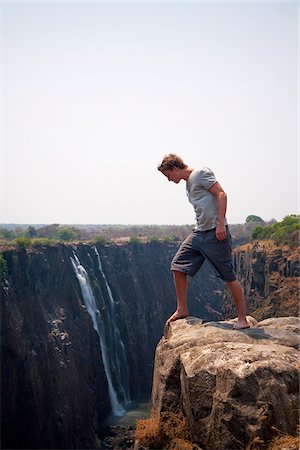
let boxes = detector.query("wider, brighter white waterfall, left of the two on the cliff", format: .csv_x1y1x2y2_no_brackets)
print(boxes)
70,252,125,416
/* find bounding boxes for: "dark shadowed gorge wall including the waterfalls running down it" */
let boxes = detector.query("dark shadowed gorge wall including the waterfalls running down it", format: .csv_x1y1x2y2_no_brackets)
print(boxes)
1,242,223,449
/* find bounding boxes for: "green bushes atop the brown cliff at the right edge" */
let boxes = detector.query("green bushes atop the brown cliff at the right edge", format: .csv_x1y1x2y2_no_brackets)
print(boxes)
251,214,300,247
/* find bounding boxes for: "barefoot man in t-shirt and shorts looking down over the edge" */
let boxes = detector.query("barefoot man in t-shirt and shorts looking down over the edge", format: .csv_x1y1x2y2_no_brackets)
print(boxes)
158,153,249,330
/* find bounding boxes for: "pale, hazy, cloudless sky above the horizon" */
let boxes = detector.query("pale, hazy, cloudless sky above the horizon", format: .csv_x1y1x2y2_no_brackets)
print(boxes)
0,0,300,224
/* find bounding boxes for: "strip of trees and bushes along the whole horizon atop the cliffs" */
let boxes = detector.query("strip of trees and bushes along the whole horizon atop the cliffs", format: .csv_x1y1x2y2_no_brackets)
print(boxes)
0,215,299,249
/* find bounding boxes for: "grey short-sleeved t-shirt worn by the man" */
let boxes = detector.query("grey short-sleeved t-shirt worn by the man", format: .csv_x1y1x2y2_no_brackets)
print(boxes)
186,167,227,231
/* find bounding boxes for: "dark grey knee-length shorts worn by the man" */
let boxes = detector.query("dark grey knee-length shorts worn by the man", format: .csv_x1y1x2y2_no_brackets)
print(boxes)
171,227,236,281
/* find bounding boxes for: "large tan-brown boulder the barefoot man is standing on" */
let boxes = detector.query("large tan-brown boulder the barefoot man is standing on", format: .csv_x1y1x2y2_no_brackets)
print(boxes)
151,317,300,450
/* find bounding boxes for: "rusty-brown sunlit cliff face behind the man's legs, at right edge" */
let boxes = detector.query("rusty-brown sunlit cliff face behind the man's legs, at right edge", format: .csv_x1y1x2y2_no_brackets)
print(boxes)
222,241,300,320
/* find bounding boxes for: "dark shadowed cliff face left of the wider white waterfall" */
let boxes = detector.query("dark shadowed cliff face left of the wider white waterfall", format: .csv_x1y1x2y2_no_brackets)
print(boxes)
1,247,110,448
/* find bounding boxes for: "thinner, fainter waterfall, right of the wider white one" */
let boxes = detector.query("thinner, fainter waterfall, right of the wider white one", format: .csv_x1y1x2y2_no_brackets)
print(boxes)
92,245,131,404
